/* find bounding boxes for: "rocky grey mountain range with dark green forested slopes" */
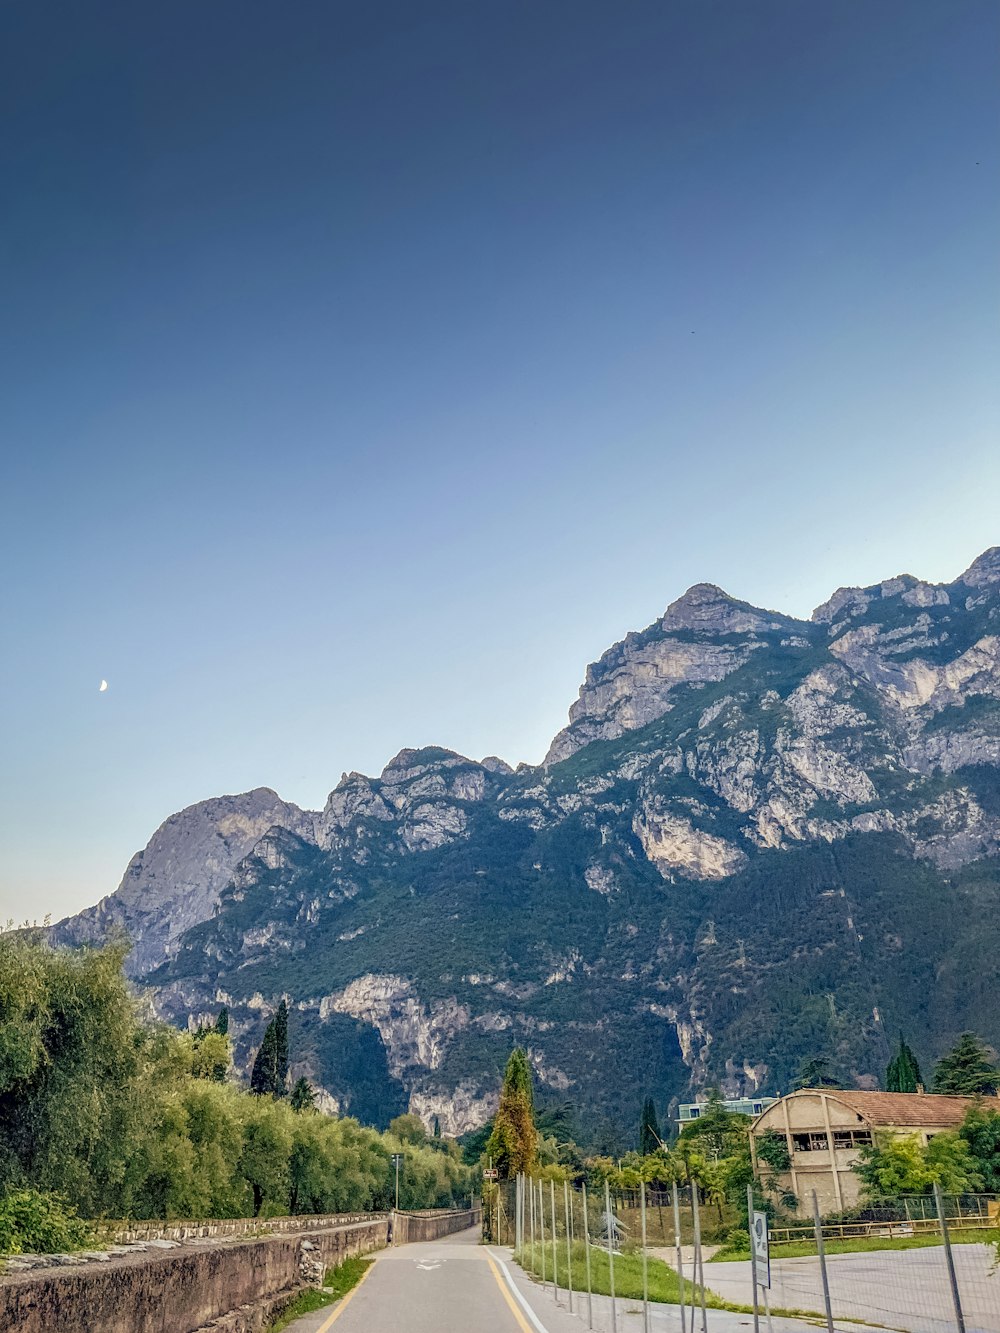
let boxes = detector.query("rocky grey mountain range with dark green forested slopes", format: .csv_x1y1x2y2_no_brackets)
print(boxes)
52,548,1000,1144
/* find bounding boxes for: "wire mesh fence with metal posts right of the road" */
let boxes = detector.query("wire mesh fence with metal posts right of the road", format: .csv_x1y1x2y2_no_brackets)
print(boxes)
484,1177,1000,1333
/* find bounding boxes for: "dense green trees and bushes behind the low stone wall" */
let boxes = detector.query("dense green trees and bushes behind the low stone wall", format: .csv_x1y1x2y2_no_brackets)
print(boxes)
0,932,473,1253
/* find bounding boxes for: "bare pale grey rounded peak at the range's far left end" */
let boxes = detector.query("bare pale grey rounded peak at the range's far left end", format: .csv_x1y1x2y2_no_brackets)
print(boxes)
52,786,315,976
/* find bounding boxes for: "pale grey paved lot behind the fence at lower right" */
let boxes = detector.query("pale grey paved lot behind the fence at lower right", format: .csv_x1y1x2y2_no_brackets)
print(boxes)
705,1245,1000,1333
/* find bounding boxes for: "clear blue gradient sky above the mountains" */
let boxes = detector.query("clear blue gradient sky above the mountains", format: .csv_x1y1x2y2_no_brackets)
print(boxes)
0,0,1000,920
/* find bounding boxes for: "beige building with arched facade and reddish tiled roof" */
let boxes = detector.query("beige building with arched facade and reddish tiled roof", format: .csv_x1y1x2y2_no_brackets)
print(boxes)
751,1088,973,1214
